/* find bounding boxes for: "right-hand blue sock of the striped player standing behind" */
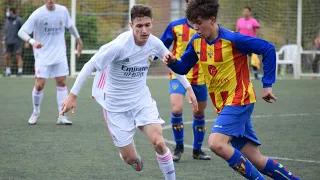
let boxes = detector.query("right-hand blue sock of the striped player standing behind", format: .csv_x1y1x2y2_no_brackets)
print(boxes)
192,114,206,150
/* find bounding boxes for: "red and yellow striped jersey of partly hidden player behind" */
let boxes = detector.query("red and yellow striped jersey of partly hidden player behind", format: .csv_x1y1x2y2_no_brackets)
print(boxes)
160,18,205,84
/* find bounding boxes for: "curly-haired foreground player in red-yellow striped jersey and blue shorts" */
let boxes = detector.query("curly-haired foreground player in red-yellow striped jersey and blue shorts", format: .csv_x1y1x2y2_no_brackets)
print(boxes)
164,0,299,180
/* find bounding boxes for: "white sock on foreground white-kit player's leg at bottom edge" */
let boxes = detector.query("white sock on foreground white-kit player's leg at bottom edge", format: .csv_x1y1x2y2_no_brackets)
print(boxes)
157,148,176,180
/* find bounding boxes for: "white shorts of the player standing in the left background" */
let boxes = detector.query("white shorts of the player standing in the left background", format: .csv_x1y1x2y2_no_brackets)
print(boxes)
34,61,69,79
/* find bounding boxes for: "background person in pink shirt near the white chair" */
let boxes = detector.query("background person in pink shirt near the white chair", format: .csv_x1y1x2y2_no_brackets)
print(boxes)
236,7,260,80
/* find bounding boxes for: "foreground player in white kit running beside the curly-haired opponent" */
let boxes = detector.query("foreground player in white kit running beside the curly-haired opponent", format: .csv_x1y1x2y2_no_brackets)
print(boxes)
62,5,198,180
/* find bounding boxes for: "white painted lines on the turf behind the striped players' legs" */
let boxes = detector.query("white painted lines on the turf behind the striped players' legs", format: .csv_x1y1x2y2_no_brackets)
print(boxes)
162,113,320,164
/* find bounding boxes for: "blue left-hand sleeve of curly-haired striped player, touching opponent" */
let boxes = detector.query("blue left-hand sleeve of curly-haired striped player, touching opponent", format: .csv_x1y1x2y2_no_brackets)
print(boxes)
168,38,199,75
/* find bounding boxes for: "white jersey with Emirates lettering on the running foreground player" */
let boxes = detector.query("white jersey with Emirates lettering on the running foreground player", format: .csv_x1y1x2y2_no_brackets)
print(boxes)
90,31,169,112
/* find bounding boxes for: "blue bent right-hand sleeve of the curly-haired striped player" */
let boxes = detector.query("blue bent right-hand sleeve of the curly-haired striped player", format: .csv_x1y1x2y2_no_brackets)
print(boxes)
234,33,276,88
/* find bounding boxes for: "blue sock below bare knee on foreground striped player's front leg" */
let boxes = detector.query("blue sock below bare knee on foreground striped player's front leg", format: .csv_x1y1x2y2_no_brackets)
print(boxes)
228,149,265,180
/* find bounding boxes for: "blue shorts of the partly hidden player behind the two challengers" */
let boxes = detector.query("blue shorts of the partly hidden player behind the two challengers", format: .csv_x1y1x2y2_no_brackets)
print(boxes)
169,79,208,102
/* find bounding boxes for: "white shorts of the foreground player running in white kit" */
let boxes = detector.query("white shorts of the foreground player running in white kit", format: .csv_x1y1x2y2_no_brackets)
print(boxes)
104,101,164,147
